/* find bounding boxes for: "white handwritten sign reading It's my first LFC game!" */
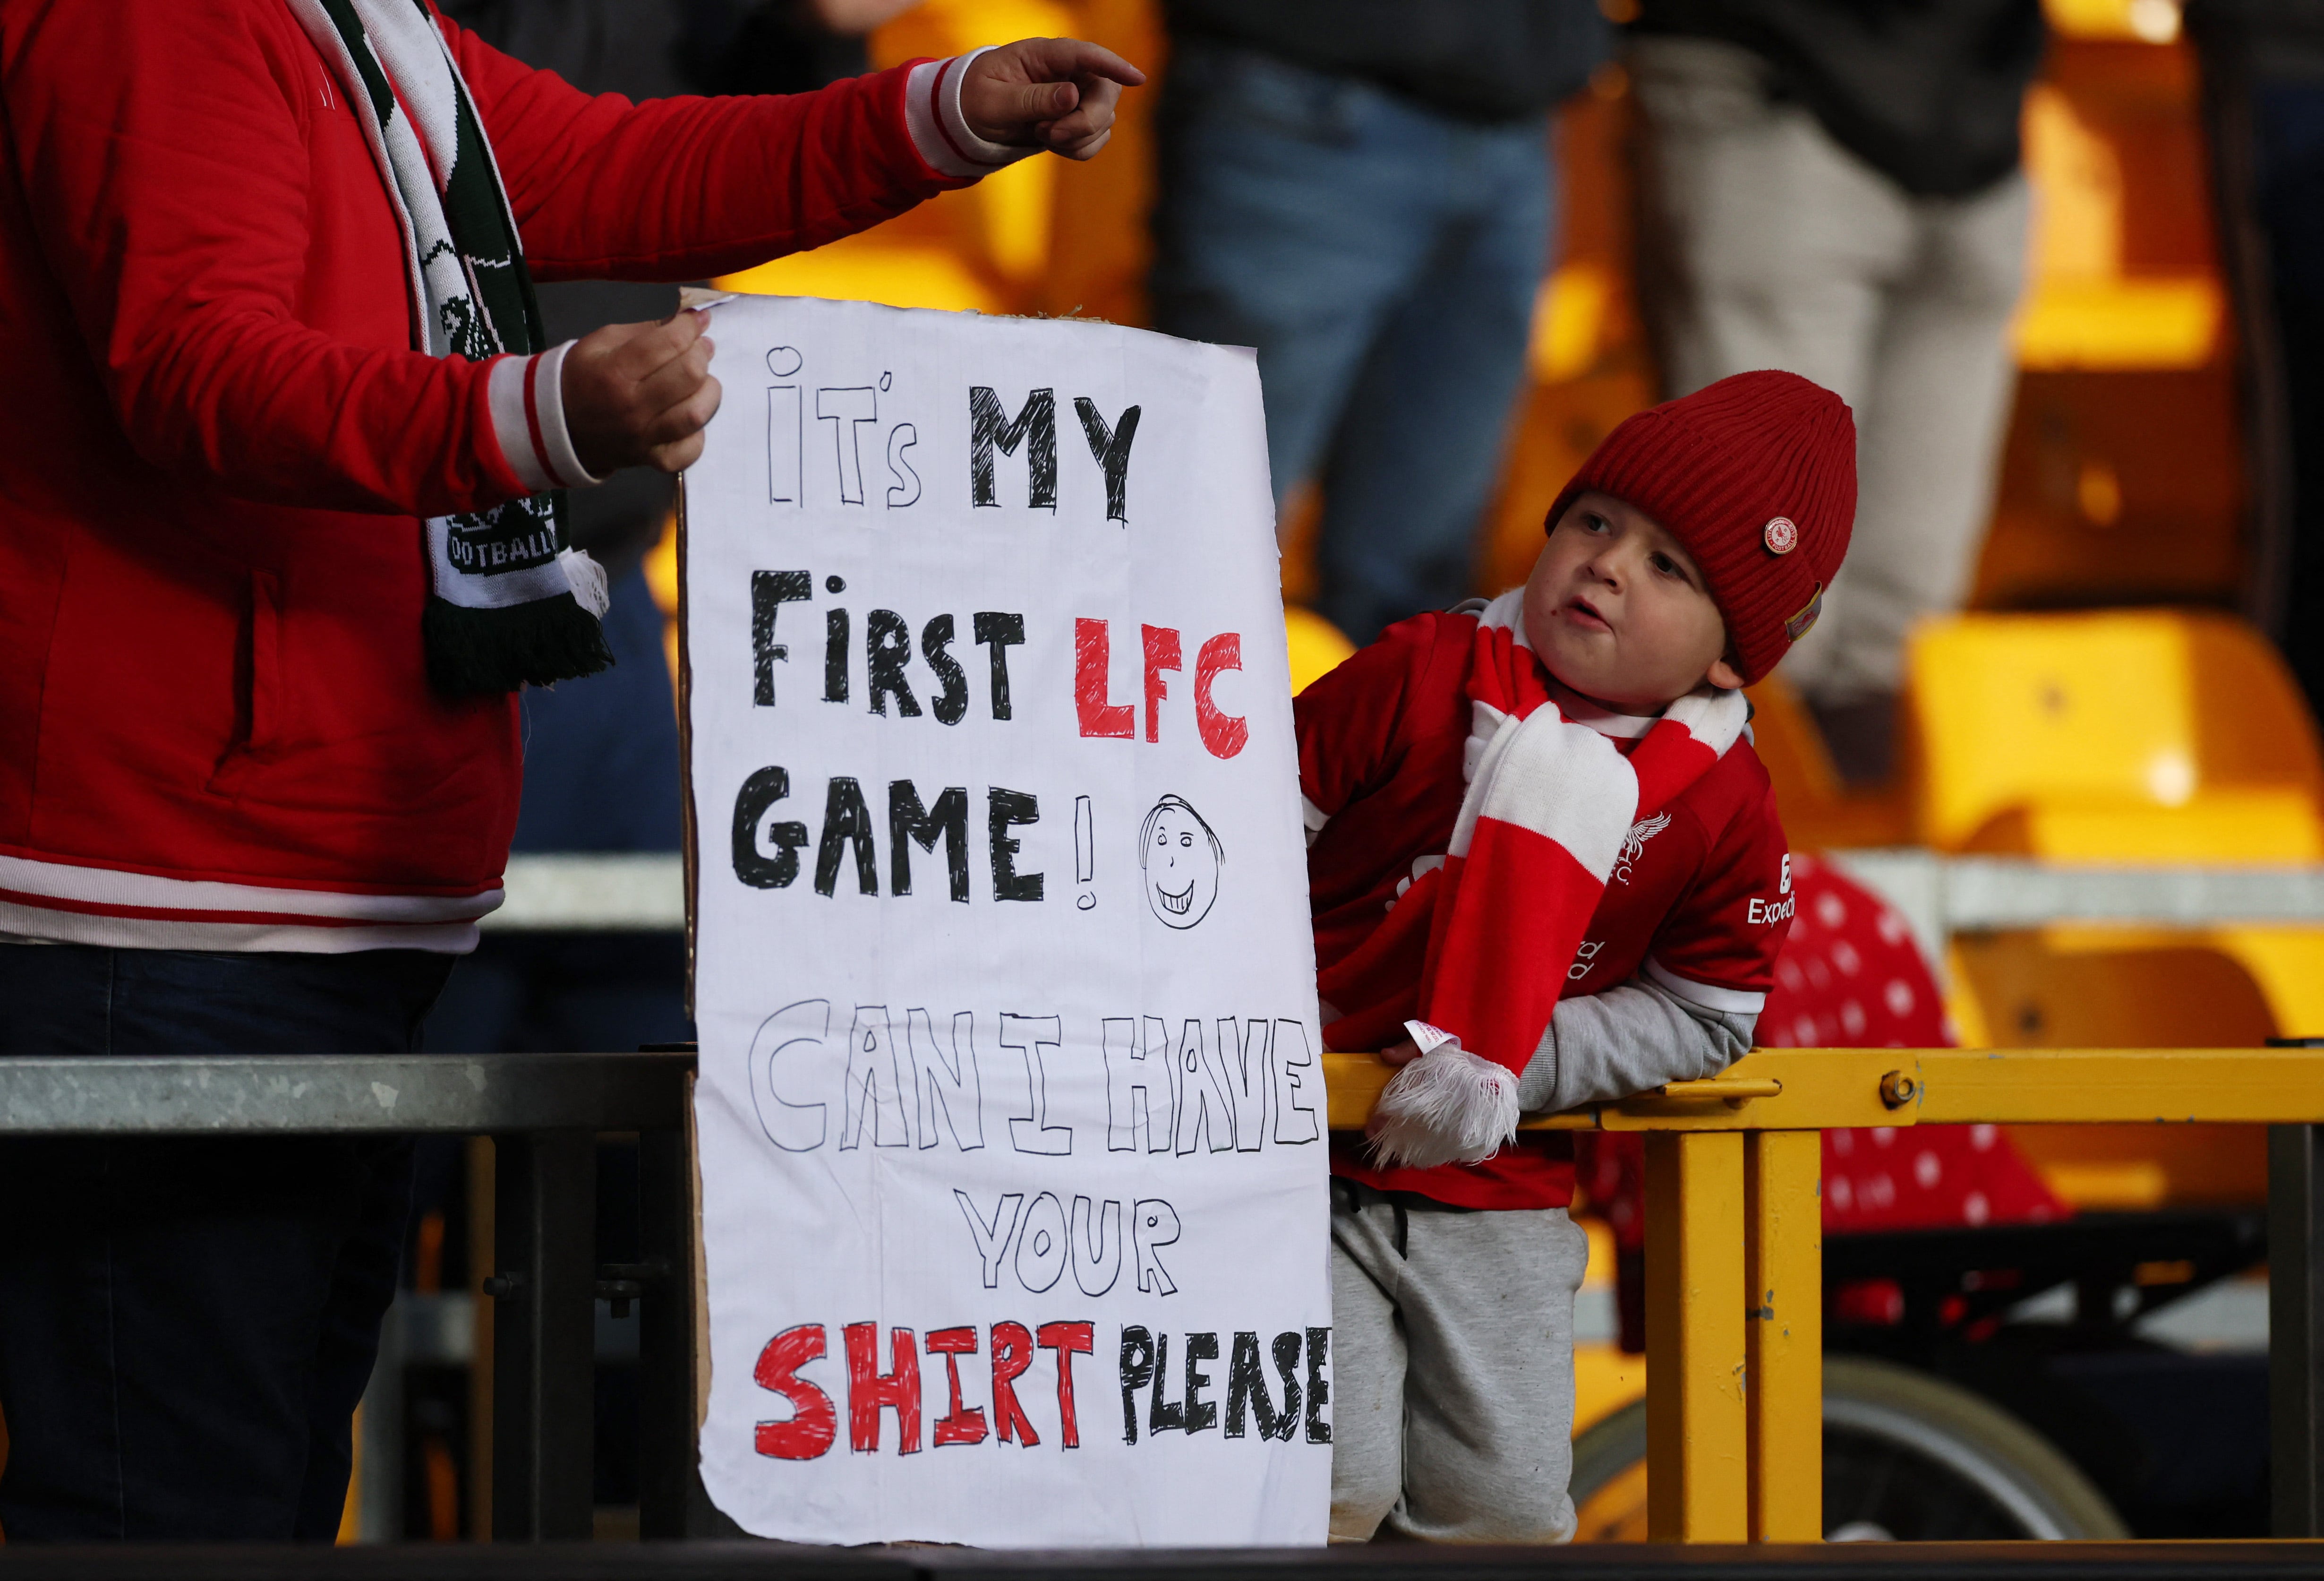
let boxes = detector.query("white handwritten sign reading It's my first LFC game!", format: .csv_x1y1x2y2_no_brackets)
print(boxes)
685,298,1332,1546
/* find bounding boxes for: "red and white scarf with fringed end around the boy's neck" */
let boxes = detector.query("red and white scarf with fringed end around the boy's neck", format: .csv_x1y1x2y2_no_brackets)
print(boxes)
1348,591,1750,1169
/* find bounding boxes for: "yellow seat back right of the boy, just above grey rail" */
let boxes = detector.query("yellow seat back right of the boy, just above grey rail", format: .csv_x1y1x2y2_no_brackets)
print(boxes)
1910,611,2324,863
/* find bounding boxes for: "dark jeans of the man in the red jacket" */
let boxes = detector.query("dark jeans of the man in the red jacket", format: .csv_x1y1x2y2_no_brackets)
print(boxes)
0,944,451,1544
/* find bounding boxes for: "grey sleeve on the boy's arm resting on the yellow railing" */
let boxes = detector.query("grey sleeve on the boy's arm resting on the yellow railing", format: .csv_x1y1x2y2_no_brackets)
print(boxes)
1518,977,1759,1114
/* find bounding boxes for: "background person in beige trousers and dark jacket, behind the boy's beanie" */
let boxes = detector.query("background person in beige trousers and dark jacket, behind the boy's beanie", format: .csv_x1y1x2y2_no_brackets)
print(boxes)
1629,0,2045,786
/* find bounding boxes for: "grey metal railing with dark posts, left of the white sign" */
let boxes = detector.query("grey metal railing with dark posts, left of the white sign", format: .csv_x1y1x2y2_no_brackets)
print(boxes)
0,1053,695,1541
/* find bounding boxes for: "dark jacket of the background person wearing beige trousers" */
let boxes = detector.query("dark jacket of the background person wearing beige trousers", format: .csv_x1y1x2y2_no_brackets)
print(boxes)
1636,0,2048,198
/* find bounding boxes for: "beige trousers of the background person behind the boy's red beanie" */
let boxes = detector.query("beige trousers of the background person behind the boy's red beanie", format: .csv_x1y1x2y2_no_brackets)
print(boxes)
1632,37,2031,705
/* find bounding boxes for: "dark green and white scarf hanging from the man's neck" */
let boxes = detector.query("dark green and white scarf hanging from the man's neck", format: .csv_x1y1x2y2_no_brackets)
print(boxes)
288,0,614,695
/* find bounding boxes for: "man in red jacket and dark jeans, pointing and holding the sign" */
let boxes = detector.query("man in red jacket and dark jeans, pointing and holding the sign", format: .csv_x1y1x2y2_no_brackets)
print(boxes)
0,0,1141,1541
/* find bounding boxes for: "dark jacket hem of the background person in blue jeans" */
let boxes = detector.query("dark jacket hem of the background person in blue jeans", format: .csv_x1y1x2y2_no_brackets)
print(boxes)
1169,0,1613,121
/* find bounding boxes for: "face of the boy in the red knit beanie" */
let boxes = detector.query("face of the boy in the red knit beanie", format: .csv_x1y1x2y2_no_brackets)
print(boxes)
1525,493,1743,714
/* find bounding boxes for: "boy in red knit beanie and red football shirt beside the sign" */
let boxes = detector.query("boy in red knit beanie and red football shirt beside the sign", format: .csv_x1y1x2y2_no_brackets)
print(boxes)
1297,372,1857,1541
